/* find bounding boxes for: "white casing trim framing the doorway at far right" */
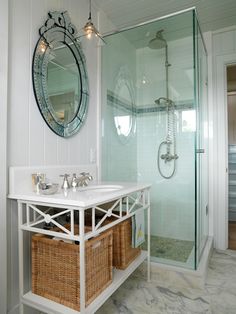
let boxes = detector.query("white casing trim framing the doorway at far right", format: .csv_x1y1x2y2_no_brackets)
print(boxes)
214,53,236,250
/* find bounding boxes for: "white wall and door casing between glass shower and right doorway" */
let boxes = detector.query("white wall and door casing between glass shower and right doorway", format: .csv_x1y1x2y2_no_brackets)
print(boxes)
207,26,236,249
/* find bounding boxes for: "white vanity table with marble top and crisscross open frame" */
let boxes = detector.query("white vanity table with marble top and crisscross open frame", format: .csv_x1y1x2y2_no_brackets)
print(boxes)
9,167,150,314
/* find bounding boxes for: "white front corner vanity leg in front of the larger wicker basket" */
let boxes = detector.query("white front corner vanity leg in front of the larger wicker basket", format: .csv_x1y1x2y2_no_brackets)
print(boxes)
79,210,85,314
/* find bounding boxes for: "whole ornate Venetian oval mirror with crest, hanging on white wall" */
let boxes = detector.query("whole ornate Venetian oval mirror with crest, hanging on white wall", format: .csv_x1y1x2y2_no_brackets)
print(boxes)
32,12,89,137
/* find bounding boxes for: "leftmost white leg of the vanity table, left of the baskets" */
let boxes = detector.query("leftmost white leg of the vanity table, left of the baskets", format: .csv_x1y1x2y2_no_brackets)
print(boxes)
18,202,24,314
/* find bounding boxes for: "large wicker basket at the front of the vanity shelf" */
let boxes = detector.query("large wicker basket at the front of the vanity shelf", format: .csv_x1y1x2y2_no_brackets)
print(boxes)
32,228,112,311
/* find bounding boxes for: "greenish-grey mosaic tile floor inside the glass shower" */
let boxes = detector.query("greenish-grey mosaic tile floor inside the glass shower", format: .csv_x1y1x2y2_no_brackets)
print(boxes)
143,236,194,263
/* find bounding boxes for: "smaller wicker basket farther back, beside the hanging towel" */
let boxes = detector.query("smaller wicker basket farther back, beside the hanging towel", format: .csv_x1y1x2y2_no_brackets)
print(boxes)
105,218,141,269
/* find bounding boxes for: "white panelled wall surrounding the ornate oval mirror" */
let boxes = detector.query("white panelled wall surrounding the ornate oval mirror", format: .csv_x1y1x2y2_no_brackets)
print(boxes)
6,0,98,313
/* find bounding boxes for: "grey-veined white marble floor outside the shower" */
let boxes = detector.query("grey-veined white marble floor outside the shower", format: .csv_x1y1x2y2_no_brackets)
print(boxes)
96,250,236,314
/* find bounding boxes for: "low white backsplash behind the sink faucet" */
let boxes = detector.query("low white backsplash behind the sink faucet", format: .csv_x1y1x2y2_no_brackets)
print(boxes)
9,164,97,194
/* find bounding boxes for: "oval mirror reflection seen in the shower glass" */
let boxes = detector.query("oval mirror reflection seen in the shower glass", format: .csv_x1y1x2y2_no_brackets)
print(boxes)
113,66,136,143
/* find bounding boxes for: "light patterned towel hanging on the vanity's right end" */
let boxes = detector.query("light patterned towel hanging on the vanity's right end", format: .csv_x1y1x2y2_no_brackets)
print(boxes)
132,211,145,248
